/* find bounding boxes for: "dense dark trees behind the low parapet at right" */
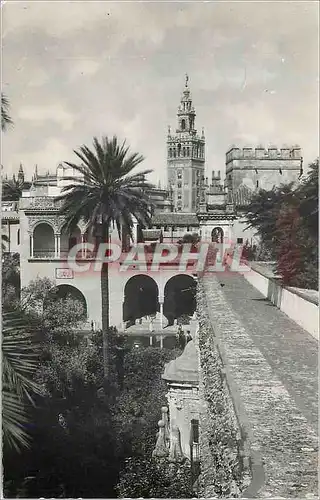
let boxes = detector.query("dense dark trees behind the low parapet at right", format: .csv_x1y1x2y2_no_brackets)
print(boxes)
245,160,319,288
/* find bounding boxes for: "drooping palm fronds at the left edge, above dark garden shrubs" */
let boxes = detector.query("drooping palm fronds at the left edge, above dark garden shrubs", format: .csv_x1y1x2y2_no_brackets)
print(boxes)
2,311,41,450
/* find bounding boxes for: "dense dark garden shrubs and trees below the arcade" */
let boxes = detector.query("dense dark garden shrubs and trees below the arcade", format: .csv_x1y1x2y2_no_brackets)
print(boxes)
4,278,185,498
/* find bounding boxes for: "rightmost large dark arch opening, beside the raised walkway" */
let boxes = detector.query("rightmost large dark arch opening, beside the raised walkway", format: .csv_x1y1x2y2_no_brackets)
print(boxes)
163,274,197,326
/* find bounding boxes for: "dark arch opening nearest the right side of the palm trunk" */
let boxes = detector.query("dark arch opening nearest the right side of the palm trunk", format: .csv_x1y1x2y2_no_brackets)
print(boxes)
123,274,160,323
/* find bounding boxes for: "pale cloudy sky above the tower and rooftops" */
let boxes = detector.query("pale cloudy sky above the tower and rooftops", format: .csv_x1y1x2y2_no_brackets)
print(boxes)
1,0,319,185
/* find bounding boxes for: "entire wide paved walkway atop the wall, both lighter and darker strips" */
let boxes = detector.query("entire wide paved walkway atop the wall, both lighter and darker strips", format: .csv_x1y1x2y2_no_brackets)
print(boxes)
202,273,318,499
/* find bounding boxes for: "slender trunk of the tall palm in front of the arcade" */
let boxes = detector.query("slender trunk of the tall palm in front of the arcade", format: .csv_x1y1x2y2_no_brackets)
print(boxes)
100,225,110,379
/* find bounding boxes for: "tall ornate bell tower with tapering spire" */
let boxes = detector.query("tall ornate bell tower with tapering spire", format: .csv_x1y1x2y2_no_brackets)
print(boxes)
167,75,205,212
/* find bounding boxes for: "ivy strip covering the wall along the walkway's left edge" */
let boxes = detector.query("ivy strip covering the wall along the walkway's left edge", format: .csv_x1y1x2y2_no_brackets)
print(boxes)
197,280,244,498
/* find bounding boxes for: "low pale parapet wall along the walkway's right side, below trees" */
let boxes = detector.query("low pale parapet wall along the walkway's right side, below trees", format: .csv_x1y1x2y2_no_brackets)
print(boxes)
242,262,319,340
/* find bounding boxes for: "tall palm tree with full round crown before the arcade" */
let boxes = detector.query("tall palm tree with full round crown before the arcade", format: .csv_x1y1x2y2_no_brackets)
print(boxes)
59,136,152,377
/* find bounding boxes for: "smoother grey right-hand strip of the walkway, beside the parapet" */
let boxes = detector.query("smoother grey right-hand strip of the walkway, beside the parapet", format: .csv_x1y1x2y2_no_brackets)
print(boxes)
217,273,318,430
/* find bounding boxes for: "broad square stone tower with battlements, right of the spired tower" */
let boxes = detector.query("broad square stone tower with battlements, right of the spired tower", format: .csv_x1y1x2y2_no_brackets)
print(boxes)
226,146,303,193
